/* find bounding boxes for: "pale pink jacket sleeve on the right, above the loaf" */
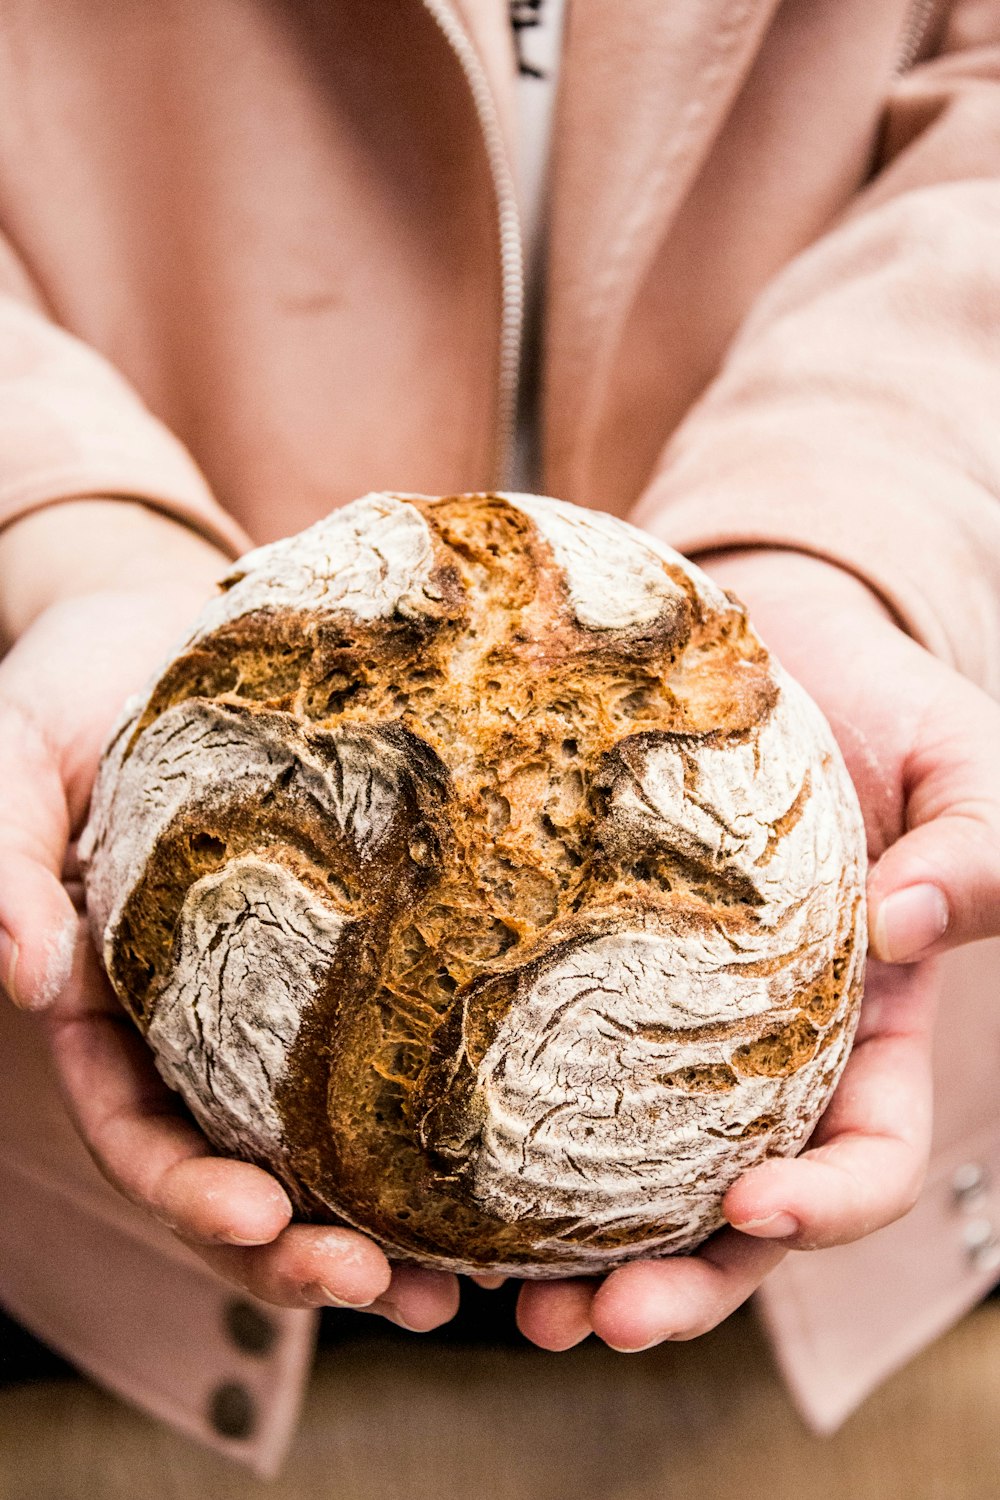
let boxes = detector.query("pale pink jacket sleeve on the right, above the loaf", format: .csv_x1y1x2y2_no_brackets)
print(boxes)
633,3,1000,692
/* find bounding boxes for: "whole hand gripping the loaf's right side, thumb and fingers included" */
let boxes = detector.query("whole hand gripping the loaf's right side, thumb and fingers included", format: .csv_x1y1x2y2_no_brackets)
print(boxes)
517,552,1000,1350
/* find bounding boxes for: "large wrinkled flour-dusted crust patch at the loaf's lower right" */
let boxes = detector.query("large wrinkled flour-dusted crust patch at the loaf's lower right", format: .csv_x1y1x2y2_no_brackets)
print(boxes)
446,930,851,1268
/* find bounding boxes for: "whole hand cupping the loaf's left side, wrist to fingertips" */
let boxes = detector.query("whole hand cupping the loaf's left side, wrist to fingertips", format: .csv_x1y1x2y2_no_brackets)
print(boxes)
0,503,459,1331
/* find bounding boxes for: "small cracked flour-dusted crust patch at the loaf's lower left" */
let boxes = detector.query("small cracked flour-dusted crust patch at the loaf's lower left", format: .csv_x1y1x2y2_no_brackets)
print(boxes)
147,855,349,1158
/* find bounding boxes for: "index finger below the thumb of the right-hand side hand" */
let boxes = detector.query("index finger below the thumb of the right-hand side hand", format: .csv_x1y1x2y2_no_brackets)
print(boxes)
723,965,936,1250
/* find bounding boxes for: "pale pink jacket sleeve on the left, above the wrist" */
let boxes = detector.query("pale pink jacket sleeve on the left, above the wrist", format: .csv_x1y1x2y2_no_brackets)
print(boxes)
0,239,250,557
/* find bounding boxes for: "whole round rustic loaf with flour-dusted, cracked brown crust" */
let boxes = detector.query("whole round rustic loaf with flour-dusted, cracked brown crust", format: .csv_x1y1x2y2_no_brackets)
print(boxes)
84,495,865,1277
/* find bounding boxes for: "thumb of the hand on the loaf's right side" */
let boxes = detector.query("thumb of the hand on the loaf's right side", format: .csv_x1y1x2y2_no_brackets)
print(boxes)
868,684,1000,963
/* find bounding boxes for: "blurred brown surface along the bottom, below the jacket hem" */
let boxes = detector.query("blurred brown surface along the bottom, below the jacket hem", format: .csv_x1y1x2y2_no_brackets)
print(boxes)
0,1301,1000,1500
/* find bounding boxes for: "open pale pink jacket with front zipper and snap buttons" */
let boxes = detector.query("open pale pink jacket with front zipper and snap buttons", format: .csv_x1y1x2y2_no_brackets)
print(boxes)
0,0,1000,1472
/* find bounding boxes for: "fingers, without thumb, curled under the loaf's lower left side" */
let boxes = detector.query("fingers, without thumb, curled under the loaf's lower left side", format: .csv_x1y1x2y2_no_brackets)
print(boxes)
48,945,459,1331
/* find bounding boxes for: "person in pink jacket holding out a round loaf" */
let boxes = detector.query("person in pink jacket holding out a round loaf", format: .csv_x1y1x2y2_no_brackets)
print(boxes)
0,0,1000,1470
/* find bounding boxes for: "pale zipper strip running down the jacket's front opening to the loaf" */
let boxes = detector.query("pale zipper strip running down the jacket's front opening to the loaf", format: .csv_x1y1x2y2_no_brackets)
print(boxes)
421,0,525,489
